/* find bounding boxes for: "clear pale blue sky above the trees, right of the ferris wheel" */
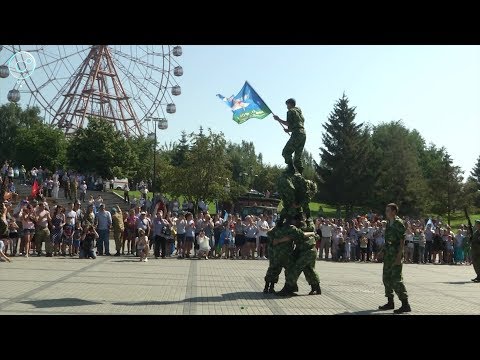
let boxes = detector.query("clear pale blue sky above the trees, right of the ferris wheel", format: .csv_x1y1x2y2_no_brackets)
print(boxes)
0,45,480,175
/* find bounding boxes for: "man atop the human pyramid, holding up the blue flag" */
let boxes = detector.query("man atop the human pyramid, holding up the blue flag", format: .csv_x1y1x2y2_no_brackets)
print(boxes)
273,99,307,174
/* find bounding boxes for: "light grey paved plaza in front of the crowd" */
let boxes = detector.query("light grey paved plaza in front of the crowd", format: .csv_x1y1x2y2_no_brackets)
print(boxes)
0,242,480,316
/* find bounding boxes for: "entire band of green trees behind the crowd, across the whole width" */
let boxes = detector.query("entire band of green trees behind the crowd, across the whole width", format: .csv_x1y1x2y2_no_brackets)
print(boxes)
0,100,480,221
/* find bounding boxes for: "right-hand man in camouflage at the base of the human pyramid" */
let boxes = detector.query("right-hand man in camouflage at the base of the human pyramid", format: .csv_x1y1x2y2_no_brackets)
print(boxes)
276,215,322,296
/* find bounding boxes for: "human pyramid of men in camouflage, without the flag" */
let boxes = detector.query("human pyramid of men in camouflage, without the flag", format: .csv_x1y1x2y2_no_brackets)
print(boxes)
263,99,322,296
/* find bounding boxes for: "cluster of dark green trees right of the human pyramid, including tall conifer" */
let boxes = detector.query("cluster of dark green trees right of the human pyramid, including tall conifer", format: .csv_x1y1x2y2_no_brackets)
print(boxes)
315,94,480,219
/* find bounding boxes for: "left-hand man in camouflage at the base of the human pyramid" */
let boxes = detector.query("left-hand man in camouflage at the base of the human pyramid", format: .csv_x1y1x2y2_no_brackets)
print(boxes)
263,226,298,293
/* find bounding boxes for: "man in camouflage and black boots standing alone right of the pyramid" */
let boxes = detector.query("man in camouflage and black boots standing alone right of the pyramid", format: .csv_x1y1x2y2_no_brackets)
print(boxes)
378,203,411,314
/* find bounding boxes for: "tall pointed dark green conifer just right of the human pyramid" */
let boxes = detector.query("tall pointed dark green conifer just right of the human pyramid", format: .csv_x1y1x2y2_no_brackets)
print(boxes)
316,94,374,217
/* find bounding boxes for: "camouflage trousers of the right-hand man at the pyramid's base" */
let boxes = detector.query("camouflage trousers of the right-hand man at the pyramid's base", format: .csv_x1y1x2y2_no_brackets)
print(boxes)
285,247,320,287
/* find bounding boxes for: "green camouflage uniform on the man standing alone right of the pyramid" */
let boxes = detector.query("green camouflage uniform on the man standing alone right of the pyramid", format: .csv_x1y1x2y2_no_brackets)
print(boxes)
383,216,408,302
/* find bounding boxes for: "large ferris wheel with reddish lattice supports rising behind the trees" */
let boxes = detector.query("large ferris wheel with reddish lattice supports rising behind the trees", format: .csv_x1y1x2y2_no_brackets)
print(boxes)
0,45,183,136
